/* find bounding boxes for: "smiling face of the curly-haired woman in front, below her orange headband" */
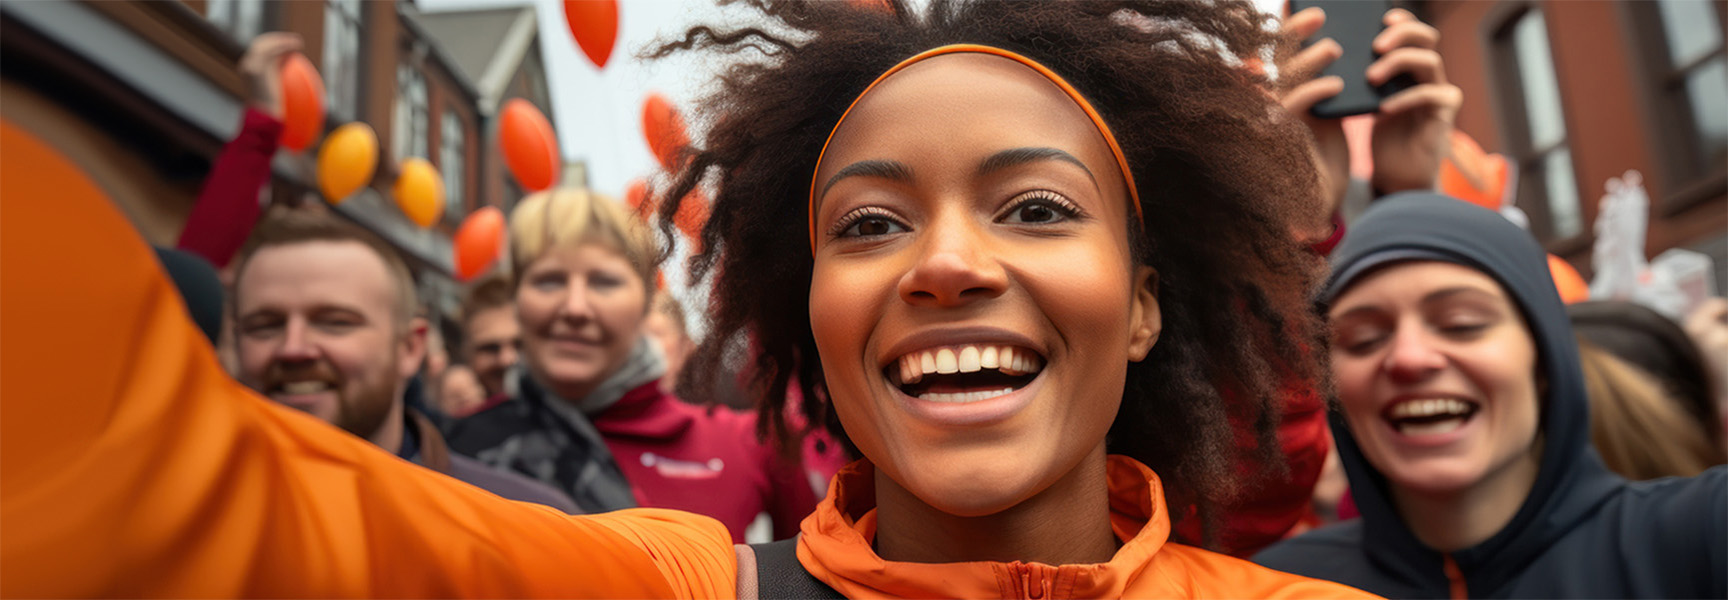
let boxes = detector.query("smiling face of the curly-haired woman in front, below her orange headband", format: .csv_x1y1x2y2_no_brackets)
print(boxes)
810,54,1159,517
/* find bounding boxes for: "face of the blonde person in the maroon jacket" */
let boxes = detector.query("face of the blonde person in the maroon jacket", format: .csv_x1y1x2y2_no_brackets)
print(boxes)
517,244,648,401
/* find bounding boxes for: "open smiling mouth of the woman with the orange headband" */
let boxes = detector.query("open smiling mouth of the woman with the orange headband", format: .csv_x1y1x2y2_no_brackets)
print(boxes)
883,344,1045,403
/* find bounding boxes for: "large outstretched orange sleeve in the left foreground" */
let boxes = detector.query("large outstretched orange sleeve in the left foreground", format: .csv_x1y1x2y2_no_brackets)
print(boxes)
0,123,736,598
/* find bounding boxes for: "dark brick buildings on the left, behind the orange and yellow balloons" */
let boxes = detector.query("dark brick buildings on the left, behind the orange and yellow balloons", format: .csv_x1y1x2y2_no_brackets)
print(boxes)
0,0,551,311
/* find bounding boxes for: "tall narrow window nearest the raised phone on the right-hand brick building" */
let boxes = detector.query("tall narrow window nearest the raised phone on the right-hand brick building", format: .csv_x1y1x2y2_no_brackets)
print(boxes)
1493,7,1585,240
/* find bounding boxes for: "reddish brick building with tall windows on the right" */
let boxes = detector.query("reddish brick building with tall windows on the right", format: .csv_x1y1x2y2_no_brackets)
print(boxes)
1403,0,1728,281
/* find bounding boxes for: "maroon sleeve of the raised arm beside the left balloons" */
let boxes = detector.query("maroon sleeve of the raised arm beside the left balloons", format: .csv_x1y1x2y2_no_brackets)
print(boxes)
176,107,282,268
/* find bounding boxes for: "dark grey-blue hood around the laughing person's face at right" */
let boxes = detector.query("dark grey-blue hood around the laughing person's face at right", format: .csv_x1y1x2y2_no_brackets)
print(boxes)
1322,192,1624,597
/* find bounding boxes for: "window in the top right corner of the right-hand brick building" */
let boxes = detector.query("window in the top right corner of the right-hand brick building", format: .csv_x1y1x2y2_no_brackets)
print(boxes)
1628,0,1728,209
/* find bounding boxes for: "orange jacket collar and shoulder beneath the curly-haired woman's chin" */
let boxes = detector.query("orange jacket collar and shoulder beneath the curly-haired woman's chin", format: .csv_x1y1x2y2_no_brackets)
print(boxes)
798,455,1367,598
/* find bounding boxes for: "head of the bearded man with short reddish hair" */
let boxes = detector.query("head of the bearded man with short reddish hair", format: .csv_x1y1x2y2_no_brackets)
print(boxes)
235,240,425,439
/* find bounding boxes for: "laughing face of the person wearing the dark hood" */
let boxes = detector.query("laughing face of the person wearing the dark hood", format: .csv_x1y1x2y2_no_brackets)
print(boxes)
1331,261,1540,500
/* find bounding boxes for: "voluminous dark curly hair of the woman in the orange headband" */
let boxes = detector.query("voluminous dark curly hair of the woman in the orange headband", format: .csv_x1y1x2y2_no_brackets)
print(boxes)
646,0,1325,539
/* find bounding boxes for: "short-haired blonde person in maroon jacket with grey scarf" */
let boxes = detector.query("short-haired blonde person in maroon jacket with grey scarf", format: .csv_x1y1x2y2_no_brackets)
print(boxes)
449,188,816,541
